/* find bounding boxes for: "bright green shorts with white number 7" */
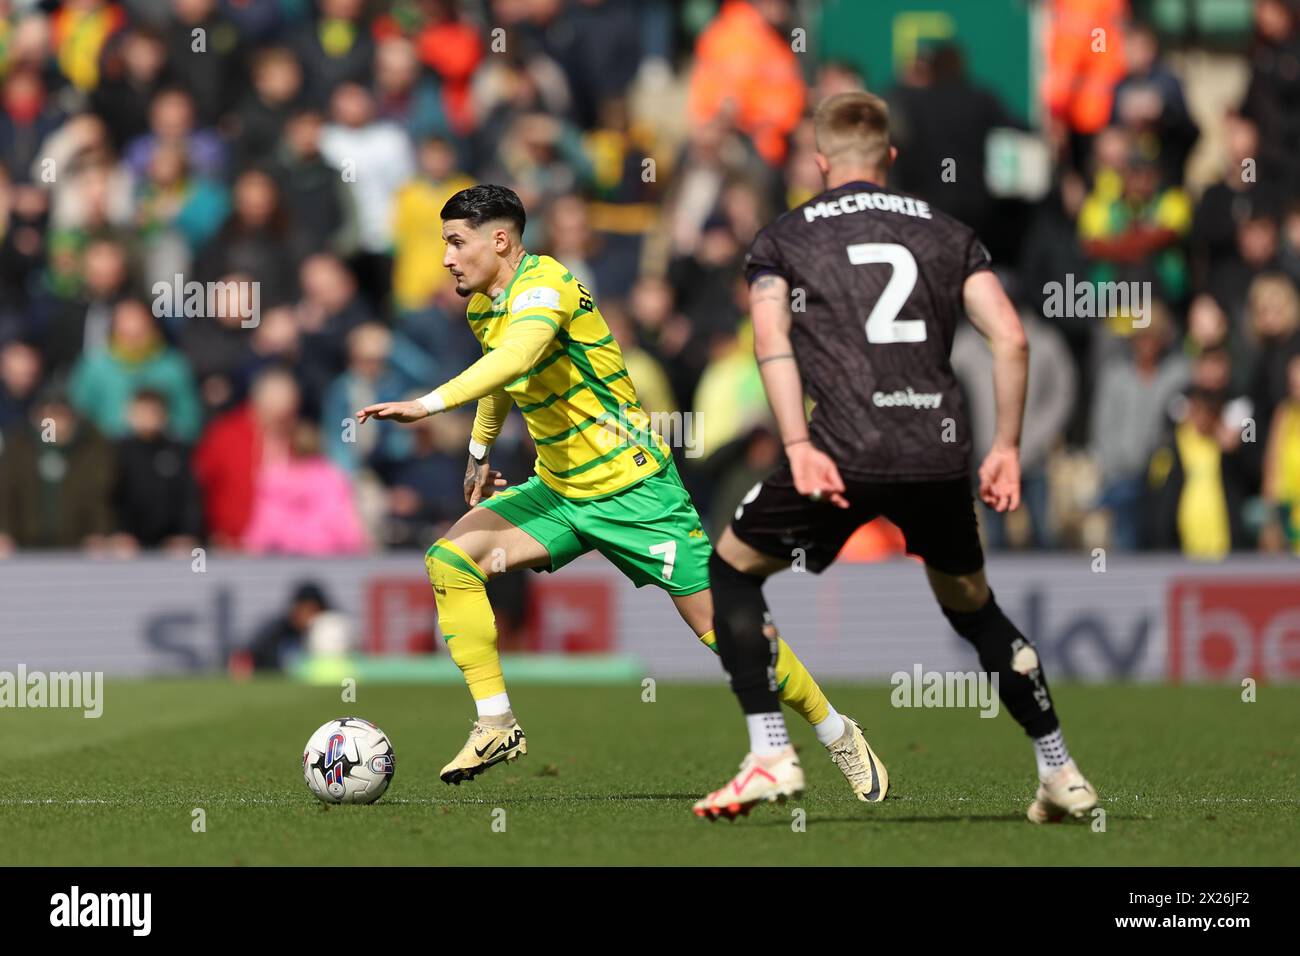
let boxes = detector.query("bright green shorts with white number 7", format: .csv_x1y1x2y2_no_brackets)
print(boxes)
477,460,712,594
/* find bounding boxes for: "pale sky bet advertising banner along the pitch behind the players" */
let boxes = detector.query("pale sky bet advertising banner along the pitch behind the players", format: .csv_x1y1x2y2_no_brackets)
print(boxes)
0,554,1300,683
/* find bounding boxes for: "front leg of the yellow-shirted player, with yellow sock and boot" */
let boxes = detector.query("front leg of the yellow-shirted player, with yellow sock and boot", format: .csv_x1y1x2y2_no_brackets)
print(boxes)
425,507,550,786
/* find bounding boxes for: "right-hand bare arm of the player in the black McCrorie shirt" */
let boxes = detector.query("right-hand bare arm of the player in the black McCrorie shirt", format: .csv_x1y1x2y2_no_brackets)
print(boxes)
962,271,1030,511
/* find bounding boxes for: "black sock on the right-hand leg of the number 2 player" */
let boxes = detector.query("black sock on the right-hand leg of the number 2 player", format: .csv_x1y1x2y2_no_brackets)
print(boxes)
943,591,1061,737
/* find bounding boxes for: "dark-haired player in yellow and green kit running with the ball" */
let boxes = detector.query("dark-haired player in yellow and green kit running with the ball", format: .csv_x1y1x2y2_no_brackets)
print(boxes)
356,185,870,799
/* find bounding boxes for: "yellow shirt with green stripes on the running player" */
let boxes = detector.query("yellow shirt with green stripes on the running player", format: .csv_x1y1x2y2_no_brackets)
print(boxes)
467,255,671,498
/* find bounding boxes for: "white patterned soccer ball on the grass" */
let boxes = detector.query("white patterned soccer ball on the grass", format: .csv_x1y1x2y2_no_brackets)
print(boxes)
303,717,394,804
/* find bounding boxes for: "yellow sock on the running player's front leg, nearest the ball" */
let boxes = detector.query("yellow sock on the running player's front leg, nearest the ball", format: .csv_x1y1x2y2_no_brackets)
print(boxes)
424,537,506,700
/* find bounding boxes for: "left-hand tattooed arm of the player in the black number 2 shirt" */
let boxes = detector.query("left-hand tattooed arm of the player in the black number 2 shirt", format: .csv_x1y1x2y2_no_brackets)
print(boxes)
749,273,849,507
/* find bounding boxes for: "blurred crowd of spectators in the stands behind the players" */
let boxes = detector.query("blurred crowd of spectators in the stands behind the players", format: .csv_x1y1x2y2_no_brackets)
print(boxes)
0,0,1300,558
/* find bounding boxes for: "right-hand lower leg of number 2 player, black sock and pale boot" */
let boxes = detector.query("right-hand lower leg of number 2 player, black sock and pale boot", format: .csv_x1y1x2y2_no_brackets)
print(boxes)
926,566,1097,823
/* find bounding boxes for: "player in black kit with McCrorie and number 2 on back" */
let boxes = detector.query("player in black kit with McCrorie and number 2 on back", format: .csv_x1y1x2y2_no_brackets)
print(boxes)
694,92,1097,823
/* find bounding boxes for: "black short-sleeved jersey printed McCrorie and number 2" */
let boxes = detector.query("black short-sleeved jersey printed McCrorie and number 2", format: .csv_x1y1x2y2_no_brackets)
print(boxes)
745,182,989,481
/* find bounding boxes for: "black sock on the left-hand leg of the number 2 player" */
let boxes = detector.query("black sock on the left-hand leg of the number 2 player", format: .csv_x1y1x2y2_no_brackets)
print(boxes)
709,551,781,714
